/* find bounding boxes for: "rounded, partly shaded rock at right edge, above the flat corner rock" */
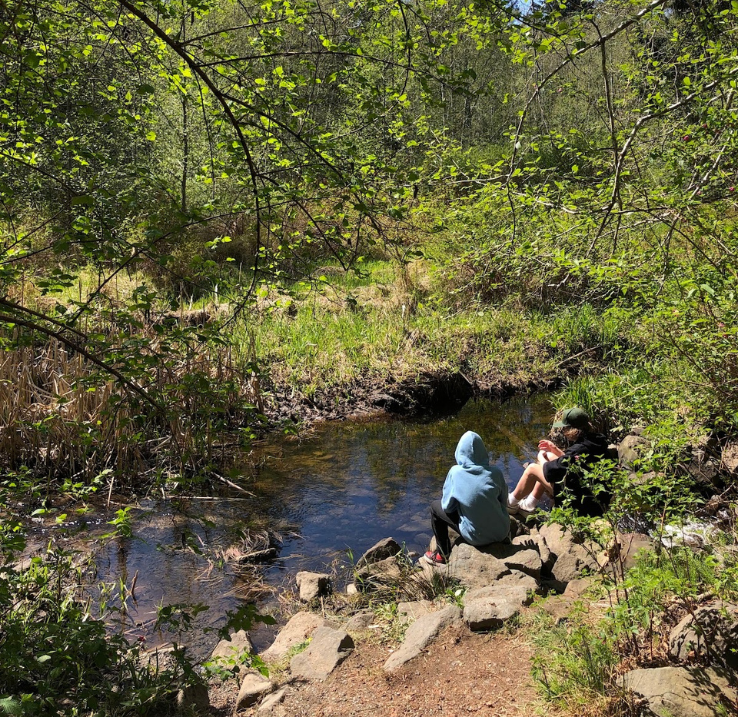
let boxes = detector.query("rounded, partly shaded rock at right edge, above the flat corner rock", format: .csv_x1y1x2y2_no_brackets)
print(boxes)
669,600,738,670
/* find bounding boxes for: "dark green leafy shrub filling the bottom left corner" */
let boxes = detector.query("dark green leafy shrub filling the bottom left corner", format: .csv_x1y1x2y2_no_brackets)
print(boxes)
0,550,185,715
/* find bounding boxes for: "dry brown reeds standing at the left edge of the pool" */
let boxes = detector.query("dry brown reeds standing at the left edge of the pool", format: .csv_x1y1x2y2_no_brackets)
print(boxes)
0,329,261,480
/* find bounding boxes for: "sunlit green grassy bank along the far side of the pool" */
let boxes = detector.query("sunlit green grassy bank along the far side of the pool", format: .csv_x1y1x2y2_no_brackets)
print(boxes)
240,261,732,454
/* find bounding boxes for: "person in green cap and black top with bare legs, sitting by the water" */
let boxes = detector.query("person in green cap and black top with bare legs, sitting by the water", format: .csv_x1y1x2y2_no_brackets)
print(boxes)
507,408,608,515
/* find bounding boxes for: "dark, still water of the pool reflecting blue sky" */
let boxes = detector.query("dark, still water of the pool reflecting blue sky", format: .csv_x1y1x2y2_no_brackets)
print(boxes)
92,395,553,649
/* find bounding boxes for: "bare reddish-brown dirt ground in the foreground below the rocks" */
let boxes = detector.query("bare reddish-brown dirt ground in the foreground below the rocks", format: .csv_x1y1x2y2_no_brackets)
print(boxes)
211,626,536,717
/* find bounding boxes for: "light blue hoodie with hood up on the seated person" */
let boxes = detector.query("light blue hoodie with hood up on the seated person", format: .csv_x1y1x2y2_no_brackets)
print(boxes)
441,431,510,545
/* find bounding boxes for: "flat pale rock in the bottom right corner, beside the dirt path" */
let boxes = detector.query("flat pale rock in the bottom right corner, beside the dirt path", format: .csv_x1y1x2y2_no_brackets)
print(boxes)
620,667,736,717
